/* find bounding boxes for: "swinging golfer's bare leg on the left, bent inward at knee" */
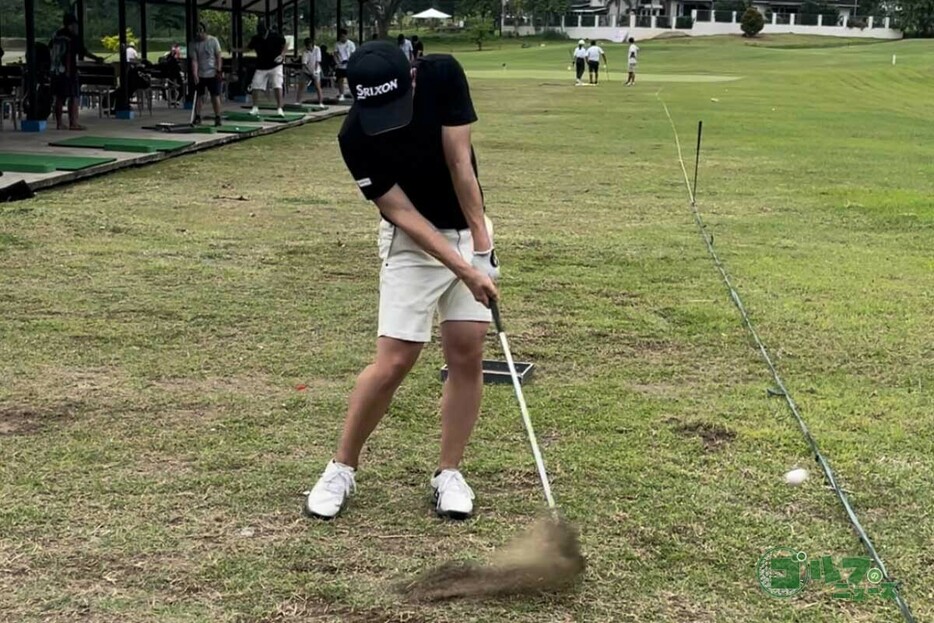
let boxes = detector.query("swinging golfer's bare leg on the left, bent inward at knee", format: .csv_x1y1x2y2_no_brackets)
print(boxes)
334,337,422,467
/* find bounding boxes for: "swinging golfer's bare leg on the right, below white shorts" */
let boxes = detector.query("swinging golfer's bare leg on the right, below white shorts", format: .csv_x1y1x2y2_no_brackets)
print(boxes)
438,321,489,469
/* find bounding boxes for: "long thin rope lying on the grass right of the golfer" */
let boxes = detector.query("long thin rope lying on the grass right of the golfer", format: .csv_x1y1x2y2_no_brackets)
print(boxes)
655,93,915,623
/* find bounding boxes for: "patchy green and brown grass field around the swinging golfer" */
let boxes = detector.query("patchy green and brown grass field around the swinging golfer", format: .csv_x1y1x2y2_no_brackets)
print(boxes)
0,38,934,623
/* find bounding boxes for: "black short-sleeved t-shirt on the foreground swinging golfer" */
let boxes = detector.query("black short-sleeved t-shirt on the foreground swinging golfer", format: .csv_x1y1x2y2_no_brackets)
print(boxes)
338,54,477,229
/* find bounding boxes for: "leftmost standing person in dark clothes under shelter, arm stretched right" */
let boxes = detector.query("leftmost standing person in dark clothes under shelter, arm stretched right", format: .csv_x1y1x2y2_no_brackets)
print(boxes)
49,13,104,130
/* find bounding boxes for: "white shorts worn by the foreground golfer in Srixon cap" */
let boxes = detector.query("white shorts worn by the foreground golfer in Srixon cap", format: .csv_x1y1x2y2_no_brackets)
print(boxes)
378,219,493,342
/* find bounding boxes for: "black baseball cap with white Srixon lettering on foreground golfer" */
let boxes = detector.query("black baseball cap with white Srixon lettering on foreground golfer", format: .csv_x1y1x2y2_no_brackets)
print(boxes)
347,41,413,136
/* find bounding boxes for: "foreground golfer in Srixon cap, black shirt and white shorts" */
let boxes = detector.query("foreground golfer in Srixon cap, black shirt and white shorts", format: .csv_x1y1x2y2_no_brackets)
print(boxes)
305,41,499,519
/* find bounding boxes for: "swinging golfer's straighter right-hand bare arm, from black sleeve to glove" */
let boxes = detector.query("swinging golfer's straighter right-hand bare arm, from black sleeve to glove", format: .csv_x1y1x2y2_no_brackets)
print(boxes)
441,125,493,251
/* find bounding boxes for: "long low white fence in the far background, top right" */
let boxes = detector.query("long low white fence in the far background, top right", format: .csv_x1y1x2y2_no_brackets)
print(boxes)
506,11,902,42
